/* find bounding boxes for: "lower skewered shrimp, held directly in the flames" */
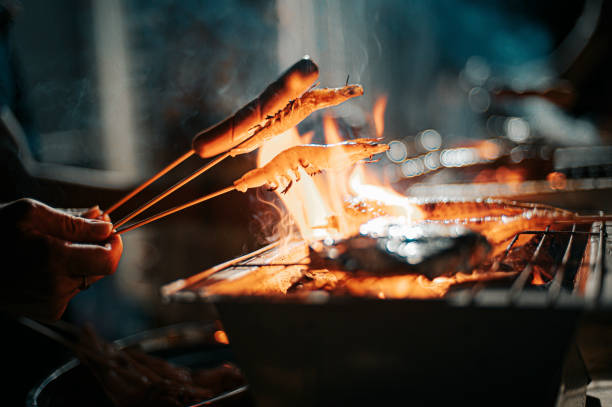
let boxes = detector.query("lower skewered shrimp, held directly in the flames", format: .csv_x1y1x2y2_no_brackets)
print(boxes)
234,138,389,193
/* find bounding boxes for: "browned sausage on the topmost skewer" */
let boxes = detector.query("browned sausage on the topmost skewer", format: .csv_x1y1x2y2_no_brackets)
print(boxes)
192,57,319,158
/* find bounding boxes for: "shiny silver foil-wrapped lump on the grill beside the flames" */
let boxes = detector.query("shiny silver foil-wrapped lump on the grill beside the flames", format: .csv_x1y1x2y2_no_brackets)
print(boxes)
311,217,491,278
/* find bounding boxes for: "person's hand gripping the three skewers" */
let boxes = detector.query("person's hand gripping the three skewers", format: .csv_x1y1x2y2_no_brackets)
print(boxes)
0,198,123,320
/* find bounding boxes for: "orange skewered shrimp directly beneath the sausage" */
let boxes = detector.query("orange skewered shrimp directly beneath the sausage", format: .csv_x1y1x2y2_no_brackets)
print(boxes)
230,85,363,157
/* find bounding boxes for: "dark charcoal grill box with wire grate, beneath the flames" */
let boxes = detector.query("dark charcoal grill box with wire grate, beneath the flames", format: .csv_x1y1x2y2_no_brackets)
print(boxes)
162,221,612,406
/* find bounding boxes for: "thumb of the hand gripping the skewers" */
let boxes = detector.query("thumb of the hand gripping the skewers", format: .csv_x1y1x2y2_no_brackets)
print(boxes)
31,203,113,242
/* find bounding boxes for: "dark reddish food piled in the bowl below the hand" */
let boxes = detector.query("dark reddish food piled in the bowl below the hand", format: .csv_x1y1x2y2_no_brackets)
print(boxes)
77,327,244,407
